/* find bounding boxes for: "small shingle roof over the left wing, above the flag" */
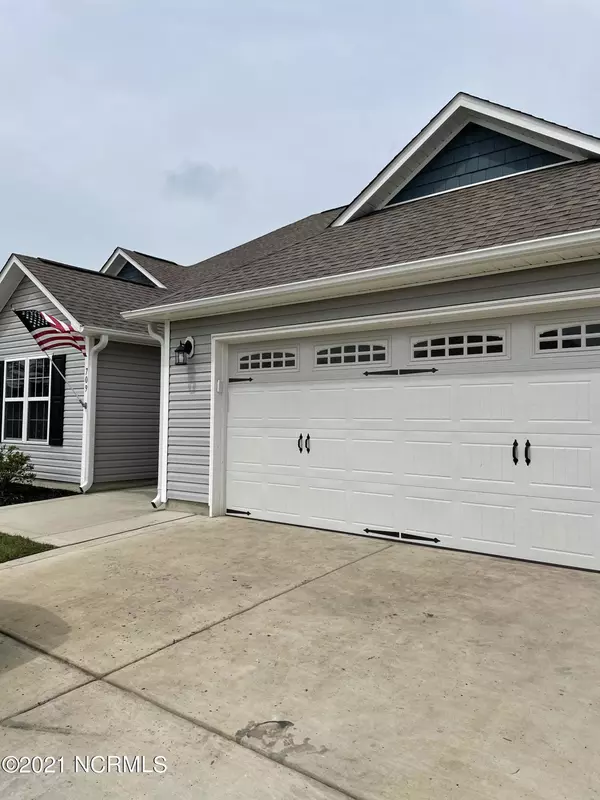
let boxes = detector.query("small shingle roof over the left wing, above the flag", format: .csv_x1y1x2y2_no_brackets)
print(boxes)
15,254,166,333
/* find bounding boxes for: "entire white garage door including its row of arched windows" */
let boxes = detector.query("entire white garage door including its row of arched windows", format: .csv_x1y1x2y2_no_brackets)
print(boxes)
226,320,600,569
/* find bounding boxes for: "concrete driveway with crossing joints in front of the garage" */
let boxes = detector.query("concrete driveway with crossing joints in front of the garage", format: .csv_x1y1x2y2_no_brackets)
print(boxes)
0,517,600,800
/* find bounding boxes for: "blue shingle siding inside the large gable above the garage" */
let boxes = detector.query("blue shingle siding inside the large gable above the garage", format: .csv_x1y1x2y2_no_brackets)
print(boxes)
390,122,567,203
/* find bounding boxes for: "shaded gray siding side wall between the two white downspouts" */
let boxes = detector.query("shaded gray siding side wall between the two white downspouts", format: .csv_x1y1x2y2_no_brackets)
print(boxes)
94,342,160,483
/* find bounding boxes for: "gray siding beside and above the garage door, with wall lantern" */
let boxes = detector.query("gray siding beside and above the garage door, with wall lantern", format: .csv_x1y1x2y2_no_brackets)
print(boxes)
167,260,600,502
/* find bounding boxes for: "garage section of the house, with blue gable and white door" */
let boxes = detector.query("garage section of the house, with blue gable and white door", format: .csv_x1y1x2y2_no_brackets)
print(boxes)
123,93,600,570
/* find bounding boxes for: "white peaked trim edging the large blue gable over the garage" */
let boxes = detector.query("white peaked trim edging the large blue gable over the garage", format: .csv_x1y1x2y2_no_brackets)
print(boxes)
332,92,600,227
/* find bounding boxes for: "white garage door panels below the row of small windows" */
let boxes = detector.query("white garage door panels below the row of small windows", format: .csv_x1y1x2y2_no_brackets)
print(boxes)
227,371,600,569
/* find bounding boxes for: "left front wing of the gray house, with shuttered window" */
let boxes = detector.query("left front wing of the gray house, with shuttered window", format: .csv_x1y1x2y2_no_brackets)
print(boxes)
0,248,187,491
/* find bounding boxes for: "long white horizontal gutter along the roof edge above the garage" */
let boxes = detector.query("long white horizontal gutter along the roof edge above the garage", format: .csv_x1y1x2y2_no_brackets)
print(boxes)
122,228,600,320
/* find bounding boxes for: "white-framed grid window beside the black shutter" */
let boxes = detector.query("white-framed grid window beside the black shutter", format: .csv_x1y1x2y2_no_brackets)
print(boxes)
2,358,51,442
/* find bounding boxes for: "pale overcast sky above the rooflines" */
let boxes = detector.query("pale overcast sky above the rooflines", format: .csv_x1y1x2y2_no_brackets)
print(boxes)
0,0,600,269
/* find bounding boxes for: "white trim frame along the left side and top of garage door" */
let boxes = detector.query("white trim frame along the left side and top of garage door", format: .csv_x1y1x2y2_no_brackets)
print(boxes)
207,289,600,517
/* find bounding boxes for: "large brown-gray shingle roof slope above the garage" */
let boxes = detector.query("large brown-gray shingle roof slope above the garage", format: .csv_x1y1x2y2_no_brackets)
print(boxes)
144,161,600,308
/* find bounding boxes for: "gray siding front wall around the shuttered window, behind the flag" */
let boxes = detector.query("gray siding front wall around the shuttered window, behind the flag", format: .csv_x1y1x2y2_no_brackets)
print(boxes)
0,278,85,484
